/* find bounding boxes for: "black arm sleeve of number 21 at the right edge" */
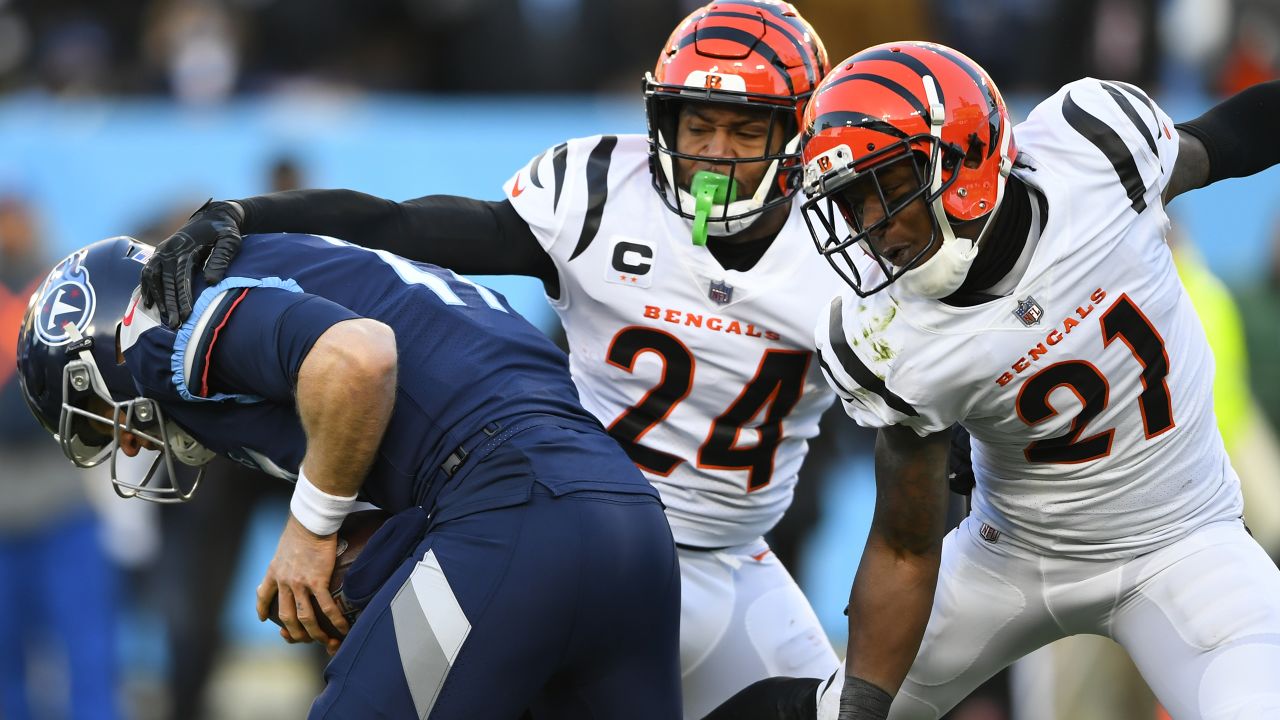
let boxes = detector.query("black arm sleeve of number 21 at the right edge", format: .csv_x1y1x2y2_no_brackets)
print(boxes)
1176,79,1280,183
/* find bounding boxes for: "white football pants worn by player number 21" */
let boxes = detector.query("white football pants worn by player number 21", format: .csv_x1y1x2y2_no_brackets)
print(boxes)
819,516,1280,720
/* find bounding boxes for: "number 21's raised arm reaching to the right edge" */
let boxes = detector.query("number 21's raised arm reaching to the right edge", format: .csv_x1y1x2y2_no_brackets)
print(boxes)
1164,81,1280,202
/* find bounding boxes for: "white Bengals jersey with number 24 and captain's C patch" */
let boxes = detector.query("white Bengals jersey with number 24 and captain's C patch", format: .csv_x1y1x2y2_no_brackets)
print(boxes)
504,135,841,547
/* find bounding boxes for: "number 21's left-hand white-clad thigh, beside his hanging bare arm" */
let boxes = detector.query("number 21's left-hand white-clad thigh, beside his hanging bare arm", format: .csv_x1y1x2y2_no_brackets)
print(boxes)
885,516,1062,720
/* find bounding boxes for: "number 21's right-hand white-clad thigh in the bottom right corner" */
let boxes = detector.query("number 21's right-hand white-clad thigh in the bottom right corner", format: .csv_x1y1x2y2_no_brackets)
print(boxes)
1112,521,1280,720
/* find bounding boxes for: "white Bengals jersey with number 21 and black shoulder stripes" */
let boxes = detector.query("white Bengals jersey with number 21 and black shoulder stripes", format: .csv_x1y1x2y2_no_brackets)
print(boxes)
817,79,1242,557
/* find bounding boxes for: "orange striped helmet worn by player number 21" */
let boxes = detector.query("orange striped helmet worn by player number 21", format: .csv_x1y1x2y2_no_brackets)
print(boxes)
804,42,1018,297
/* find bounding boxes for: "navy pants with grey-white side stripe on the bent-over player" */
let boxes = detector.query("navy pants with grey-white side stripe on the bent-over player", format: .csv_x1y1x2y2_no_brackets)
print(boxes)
311,488,680,720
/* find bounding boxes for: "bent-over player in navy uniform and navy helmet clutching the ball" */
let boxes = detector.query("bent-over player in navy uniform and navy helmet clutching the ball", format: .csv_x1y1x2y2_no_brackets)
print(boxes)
18,234,680,720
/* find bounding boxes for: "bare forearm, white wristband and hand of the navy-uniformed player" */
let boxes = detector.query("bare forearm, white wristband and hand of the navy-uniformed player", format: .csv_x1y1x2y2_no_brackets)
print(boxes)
257,318,397,652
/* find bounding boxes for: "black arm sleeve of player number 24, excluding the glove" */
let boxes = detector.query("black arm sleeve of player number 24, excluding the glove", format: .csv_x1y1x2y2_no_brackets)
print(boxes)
237,190,558,289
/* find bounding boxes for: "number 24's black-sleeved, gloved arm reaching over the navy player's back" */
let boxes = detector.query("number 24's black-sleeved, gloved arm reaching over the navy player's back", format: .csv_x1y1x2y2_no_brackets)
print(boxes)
142,190,558,328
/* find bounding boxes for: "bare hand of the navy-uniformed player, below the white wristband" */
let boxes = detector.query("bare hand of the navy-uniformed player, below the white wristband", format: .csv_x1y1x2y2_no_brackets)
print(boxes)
257,507,351,655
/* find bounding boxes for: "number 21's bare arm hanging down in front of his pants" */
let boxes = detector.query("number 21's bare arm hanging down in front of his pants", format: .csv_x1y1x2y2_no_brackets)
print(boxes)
840,427,951,720
